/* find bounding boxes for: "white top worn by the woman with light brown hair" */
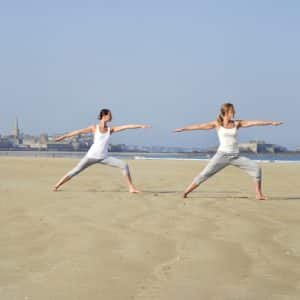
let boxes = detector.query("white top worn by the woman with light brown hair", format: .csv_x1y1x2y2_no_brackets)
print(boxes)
217,125,239,153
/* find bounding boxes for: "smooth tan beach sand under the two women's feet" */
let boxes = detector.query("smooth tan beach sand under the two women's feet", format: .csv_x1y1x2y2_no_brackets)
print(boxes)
0,158,300,300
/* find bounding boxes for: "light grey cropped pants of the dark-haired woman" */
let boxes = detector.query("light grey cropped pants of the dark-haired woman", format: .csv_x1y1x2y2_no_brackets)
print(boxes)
67,156,129,177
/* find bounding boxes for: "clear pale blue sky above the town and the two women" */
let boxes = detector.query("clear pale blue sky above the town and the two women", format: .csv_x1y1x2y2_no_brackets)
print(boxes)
0,0,300,149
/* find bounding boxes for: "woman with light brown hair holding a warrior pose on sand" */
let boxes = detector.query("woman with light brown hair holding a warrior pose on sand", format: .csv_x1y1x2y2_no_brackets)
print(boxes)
175,103,282,200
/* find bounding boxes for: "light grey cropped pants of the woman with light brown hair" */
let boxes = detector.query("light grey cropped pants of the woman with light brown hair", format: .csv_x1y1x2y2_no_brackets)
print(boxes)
193,152,261,185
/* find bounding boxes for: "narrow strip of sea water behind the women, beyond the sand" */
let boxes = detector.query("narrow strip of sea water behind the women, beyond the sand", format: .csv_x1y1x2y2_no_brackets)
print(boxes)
0,151,300,163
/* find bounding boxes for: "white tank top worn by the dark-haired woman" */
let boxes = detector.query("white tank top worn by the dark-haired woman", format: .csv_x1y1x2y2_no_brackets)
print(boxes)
87,125,111,159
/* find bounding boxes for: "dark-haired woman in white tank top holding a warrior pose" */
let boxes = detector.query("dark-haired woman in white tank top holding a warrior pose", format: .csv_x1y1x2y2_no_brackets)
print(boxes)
53,109,150,193
